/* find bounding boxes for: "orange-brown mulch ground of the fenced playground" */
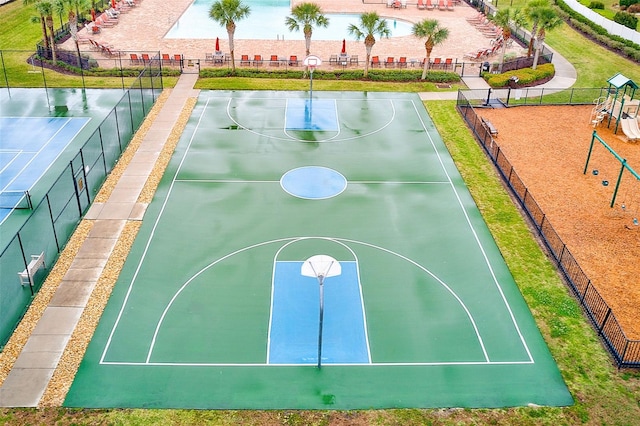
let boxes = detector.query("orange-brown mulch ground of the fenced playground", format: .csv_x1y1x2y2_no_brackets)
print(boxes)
478,106,640,340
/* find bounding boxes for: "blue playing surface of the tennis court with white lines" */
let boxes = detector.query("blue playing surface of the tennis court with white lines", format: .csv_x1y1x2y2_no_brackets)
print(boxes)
0,117,90,223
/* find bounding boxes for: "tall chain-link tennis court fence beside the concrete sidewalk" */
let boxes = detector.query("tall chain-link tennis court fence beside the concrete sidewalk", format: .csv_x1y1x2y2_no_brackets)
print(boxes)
0,61,162,349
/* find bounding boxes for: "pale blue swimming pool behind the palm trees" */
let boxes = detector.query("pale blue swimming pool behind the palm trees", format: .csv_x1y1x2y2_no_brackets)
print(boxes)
165,0,412,40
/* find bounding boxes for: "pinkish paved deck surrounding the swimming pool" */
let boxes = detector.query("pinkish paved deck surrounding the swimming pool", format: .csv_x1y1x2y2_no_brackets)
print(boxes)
63,0,522,66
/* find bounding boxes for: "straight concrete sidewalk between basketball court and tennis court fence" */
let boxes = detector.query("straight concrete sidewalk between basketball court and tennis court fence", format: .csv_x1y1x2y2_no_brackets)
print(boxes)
0,74,198,407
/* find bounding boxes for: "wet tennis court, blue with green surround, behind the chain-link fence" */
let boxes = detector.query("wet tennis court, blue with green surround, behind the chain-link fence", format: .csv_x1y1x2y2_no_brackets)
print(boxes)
0,89,129,236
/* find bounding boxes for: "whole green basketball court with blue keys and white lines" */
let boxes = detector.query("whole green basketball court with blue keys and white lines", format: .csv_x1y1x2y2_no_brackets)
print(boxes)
65,91,573,409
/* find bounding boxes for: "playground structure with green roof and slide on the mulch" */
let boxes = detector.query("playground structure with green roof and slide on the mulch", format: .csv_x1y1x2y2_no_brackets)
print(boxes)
591,73,640,140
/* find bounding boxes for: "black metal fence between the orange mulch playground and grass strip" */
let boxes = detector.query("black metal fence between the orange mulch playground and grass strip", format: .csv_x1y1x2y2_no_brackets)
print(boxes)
457,91,640,368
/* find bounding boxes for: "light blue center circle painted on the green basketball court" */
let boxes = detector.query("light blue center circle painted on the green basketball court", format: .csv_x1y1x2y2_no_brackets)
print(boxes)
280,166,347,200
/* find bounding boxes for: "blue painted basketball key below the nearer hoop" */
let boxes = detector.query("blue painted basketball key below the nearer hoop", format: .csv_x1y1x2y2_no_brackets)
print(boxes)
267,262,371,364
